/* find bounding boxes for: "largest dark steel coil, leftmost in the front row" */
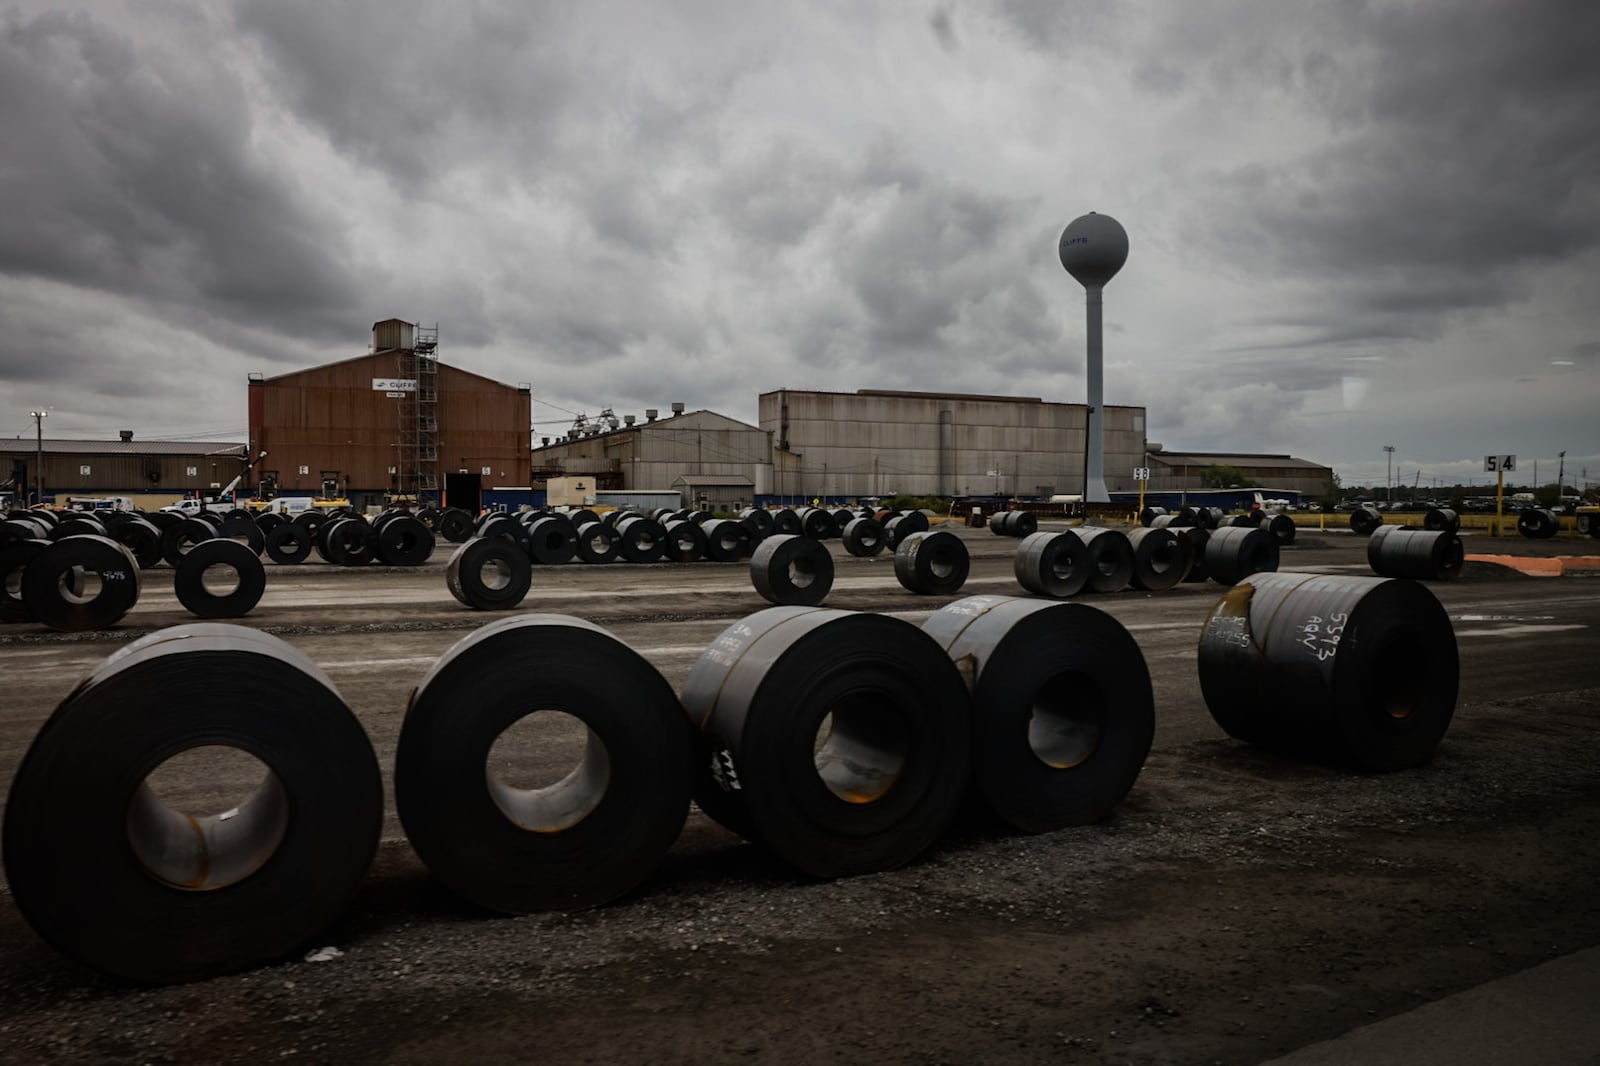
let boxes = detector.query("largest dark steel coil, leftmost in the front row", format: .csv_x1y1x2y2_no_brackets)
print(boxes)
5,623,384,983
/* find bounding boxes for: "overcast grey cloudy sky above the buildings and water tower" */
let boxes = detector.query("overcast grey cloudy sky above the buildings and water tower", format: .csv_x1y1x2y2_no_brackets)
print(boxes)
0,0,1600,485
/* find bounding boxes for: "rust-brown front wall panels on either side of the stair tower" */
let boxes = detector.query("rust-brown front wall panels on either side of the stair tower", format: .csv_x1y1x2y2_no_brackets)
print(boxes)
250,351,531,495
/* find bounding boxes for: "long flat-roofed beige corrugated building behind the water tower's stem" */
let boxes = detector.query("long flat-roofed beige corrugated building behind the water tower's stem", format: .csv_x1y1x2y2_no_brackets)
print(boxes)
760,389,1144,498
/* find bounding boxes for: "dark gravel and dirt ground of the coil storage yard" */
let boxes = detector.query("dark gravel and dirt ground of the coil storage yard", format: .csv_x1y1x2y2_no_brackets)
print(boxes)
0,530,1600,1063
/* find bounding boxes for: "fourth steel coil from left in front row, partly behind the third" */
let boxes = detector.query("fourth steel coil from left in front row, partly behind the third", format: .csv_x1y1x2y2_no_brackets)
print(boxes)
922,595,1155,832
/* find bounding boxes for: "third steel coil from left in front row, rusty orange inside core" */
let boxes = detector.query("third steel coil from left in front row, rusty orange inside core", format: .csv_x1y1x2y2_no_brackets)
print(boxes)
682,607,973,877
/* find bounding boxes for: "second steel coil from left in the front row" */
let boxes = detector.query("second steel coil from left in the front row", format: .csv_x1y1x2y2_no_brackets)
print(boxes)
394,615,693,914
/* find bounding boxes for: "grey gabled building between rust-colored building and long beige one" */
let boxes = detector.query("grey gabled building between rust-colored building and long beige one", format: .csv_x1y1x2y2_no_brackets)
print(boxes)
533,403,773,511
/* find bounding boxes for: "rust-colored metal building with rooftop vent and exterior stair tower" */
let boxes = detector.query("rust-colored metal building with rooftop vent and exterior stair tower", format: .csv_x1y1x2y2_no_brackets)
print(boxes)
250,319,533,511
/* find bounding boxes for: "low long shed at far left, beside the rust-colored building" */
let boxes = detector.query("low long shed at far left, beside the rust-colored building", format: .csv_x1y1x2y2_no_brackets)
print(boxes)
0,429,245,507
